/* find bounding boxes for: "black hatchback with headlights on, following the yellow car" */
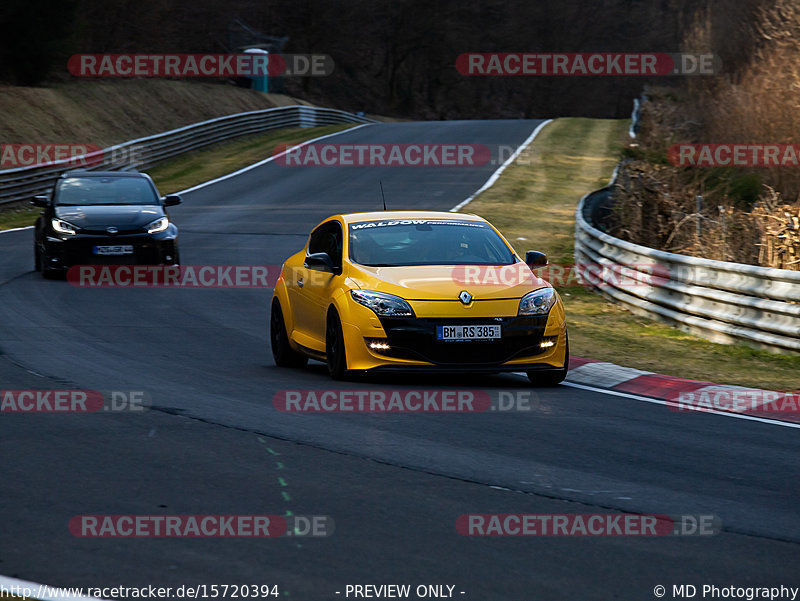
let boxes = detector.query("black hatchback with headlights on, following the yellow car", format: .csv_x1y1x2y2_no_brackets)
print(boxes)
33,171,181,277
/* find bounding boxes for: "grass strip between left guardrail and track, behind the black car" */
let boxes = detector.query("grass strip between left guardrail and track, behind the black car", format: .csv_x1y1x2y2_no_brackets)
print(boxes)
0,124,353,230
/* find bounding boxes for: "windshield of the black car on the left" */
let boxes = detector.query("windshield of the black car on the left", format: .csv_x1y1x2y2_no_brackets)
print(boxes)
56,177,159,206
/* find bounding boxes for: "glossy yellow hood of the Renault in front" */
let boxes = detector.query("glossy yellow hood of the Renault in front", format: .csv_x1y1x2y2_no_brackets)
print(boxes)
350,263,550,301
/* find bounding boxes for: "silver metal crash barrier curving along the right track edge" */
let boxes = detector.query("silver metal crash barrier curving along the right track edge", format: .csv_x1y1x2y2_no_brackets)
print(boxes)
575,187,800,353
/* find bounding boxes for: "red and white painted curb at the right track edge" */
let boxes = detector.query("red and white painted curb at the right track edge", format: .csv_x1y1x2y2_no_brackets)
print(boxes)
566,357,800,424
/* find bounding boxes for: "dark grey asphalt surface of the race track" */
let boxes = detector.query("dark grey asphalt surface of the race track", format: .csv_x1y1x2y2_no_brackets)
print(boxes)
0,120,800,601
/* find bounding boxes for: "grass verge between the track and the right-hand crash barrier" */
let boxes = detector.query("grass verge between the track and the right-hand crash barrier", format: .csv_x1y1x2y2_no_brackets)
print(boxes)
463,118,800,390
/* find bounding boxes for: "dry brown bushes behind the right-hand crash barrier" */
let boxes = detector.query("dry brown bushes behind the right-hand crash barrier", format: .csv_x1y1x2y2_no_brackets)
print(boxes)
608,0,800,270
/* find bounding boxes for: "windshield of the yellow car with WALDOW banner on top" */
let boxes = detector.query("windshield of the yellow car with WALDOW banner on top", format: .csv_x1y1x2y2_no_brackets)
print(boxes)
350,219,516,267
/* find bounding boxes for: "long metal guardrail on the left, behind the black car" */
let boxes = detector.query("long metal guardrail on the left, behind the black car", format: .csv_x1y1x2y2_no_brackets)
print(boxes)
0,105,377,205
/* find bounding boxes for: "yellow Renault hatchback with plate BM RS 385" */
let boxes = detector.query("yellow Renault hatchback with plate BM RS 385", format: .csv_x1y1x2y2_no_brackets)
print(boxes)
270,211,569,385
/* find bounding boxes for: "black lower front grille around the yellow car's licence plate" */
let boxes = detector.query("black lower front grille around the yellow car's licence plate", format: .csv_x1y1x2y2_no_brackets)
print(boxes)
379,315,547,367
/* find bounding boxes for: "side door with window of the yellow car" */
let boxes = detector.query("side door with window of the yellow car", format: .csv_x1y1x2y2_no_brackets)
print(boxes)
295,220,343,351
